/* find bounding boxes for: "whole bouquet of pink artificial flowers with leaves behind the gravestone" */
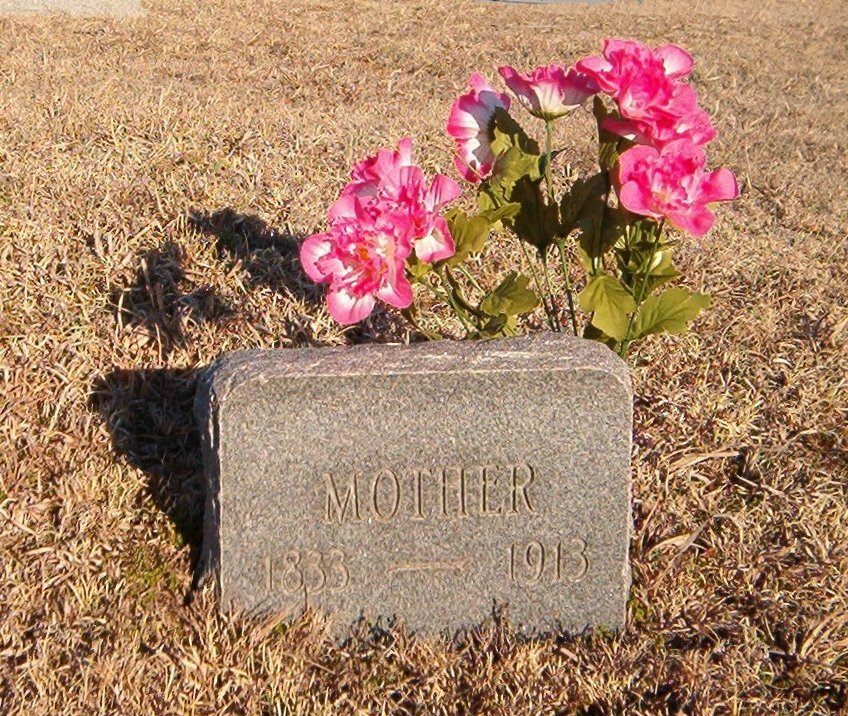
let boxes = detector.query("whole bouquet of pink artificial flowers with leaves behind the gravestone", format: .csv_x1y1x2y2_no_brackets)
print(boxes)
300,39,739,357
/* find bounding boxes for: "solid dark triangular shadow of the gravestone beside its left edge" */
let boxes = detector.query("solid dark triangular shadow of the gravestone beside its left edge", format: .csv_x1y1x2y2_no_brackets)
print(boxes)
91,368,205,589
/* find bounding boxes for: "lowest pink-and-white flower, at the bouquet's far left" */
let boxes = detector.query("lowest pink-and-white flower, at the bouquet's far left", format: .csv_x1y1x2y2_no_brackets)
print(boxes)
300,195,412,324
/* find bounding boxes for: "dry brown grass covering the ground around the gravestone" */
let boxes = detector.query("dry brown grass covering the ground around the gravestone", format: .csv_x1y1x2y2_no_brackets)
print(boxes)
0,0,848,714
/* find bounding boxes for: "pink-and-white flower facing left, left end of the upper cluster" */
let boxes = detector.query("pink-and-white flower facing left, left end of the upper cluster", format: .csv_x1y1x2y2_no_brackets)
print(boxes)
446,72,510,183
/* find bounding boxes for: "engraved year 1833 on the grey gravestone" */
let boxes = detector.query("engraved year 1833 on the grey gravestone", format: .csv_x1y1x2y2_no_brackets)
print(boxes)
264,548,350,597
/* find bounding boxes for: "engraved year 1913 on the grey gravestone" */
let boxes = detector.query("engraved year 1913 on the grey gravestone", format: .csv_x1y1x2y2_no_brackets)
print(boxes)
509,537,589,585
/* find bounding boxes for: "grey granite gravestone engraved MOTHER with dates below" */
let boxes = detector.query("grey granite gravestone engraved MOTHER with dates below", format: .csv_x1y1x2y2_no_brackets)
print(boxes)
197,334,632,635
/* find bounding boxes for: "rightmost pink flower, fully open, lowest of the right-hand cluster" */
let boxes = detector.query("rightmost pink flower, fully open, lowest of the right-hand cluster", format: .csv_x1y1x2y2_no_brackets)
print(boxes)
615,139,739,236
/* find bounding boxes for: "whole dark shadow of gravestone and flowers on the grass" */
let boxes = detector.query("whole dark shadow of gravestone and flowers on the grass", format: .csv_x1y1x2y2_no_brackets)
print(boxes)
91,208,319,599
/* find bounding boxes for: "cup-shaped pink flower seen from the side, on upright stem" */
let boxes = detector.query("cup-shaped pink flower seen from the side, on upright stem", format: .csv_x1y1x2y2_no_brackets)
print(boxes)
498,65,598,120
